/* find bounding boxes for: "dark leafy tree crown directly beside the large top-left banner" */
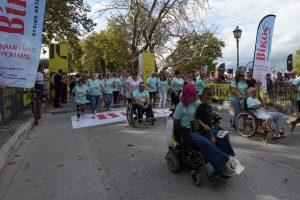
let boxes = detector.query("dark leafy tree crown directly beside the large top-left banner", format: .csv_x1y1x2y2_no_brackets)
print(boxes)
43,0,95,44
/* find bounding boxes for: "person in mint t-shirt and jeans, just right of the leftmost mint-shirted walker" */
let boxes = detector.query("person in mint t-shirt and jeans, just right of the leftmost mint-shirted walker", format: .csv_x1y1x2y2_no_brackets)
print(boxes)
87,73,102,119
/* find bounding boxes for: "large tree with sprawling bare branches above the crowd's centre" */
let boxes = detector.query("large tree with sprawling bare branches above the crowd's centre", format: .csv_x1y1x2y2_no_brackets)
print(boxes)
98,0,207,67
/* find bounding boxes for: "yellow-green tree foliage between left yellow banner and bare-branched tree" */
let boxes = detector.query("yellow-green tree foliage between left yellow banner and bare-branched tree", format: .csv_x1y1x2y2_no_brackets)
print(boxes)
81,20,132,72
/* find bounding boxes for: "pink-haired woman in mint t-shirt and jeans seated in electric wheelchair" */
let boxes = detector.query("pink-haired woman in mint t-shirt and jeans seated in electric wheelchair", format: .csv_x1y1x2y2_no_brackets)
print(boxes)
173,84,244,177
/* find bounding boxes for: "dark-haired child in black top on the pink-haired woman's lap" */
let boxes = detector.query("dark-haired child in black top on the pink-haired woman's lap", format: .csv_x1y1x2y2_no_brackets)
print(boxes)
196,88,234,146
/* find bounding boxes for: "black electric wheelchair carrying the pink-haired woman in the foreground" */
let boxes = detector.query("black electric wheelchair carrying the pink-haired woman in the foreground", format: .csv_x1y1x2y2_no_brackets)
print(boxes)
165,110,230,186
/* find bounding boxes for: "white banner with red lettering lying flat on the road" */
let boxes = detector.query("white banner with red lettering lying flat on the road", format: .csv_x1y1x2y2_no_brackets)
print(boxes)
71,109,171,129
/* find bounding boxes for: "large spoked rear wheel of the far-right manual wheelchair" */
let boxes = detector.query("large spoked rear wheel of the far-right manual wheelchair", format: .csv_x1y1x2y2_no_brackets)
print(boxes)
236,112,258,138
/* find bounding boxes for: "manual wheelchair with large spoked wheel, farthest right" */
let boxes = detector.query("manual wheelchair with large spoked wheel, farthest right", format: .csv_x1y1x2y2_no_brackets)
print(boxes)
236,98,282,143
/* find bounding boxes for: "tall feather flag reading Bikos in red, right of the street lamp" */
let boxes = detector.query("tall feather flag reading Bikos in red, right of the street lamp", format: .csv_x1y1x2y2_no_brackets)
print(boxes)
253,15,276,93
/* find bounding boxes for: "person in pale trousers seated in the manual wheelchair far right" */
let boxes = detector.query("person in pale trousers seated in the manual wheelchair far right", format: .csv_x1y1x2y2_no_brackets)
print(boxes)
246,87,286,138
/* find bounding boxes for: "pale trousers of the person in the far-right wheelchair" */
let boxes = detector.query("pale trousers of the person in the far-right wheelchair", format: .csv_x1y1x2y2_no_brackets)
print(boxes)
254,110,283,131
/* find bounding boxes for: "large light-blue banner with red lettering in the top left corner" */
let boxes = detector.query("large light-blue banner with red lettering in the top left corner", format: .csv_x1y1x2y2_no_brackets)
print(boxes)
0,0,46,88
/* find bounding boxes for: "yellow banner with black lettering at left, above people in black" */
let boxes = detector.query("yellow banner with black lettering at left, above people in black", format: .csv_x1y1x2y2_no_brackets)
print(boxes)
49,44,69,72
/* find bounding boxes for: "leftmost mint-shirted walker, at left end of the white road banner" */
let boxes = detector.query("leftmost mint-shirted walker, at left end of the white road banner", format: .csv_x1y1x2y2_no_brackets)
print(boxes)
72,79,89,121
